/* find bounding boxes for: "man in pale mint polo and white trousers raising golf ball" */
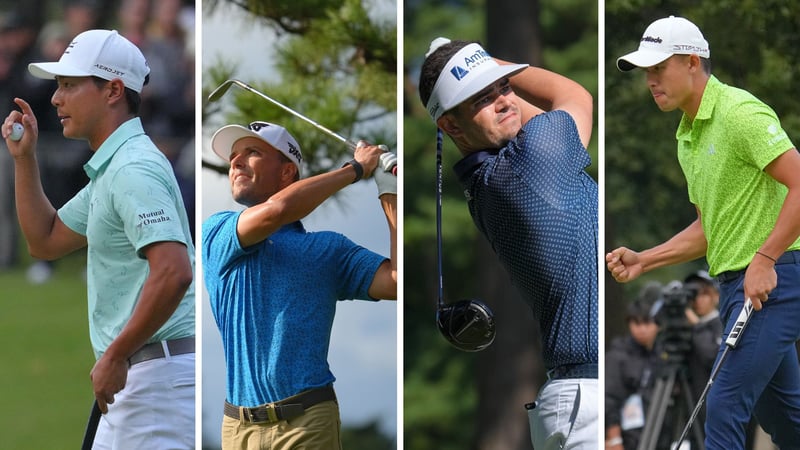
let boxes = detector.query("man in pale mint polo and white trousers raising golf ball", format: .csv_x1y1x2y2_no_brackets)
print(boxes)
2,30,195,449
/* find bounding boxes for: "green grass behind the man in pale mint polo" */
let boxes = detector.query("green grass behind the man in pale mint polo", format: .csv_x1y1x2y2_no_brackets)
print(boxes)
0,252,94,449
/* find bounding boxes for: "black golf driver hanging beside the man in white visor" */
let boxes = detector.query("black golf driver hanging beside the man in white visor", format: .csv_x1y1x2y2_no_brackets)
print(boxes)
436,129,495,352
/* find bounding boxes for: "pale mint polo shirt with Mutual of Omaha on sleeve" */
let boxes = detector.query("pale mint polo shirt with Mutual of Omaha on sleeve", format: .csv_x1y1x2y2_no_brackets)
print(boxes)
58,118,195,358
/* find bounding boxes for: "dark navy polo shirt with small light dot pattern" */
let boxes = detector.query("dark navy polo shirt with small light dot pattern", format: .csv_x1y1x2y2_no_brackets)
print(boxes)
455,111,598,369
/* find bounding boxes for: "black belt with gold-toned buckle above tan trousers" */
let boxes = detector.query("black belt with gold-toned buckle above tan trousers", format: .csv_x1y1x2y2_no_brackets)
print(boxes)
225,385,336,423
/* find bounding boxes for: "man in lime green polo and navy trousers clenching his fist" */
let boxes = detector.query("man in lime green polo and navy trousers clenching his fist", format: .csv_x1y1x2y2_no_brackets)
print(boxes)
606,16,800,450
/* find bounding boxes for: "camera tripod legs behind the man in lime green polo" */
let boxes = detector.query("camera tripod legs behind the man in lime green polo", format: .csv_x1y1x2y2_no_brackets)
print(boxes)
637,363,705,450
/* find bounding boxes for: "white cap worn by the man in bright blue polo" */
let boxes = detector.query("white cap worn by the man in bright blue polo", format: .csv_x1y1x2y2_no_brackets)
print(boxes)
211,122,303,174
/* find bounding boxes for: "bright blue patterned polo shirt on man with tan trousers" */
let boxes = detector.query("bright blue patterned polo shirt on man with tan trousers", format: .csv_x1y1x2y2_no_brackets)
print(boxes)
202,211,386,407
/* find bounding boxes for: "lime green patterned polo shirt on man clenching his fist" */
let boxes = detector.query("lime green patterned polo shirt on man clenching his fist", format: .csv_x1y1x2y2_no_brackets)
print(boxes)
676,75,800,276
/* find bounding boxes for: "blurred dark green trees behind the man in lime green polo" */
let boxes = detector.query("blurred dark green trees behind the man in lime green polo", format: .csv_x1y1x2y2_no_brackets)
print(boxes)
605,0,800,342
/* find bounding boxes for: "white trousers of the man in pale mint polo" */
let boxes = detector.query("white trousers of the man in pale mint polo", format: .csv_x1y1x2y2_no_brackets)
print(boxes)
92,353,195,450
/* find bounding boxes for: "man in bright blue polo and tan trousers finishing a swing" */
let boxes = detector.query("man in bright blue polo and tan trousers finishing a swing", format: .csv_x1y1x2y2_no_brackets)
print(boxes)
202,122,397,450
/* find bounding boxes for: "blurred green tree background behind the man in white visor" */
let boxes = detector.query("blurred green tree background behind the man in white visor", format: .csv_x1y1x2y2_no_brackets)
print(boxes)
403,0,598,450
